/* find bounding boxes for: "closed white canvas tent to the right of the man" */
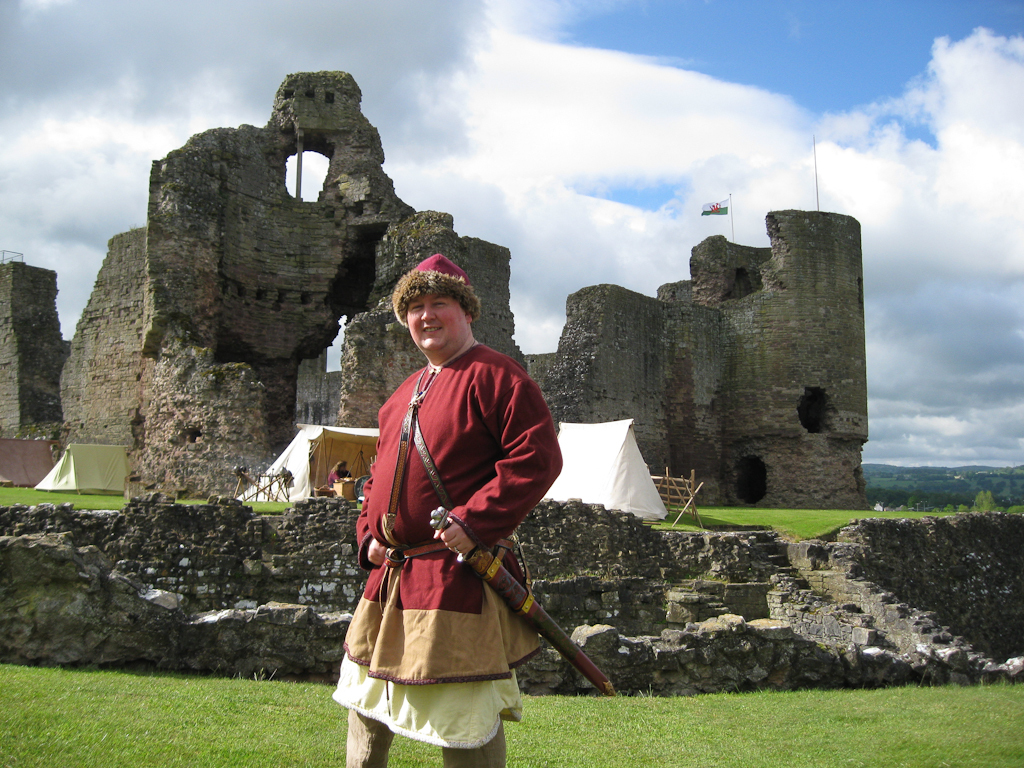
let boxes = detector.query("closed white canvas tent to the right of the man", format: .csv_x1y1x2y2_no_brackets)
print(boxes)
546,419,668,520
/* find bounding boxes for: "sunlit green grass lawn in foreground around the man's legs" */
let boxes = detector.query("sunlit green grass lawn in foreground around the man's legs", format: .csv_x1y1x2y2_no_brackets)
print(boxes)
0,665,1024,768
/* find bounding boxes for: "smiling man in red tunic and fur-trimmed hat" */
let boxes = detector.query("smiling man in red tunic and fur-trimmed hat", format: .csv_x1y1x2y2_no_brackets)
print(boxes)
334,254,562,768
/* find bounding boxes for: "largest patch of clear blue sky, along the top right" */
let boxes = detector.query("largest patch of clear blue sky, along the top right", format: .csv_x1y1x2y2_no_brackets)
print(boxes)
564,0,1024,113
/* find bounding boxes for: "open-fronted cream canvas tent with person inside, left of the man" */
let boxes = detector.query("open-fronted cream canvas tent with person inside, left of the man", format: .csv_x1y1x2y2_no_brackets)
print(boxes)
256,424,379,502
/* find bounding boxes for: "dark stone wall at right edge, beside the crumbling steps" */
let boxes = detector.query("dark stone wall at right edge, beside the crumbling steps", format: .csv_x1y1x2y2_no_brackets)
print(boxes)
790,520,1024,658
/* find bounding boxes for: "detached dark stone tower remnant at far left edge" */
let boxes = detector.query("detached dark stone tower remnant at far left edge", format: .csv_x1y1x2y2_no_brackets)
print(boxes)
0,261,67,437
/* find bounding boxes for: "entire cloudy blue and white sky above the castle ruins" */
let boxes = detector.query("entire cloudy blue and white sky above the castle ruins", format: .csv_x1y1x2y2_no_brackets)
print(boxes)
0,0,1024,466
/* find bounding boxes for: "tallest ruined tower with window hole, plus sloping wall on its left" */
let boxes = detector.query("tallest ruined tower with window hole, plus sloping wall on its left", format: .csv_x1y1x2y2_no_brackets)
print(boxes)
61,72,520,495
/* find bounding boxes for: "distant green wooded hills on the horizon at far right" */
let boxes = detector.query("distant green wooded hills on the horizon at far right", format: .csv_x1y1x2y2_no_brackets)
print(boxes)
861,464,1024,507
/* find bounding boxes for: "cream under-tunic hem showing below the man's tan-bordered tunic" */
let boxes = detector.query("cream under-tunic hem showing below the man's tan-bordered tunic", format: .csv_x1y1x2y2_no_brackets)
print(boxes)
334,656,522,750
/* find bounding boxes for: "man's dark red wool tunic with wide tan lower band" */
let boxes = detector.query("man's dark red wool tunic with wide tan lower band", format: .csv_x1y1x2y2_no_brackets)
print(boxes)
346,345,562,684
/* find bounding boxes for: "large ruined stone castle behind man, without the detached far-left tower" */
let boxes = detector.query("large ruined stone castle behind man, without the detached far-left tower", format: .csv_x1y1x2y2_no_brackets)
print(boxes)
36,72,867,508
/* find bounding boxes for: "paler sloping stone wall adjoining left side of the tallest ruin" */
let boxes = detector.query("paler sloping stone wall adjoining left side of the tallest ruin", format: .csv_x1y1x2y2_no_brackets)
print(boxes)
60,228,152,447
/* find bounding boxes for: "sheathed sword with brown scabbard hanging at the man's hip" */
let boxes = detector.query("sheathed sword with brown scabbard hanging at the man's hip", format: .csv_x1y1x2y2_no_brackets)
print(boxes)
430,507,615,696
